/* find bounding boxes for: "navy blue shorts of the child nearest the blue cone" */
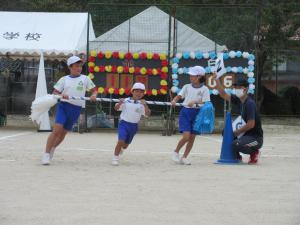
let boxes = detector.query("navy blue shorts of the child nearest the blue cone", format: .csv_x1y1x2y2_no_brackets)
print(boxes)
179,107,199,134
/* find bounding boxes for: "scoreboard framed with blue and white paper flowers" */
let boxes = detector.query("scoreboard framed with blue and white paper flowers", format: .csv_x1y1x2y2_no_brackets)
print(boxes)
171,51,255,95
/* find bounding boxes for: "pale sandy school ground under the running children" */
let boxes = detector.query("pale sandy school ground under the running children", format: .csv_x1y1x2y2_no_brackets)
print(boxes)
0,129,300,225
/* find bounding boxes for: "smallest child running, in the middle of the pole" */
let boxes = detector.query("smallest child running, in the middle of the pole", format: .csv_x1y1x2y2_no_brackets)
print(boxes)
112,83,151,166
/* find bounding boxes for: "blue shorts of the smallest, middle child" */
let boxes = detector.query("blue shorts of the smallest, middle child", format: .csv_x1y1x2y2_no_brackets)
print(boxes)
118,120,138,144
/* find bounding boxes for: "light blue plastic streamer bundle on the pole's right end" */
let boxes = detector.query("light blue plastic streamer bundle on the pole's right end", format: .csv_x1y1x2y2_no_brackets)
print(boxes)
193,102,215,134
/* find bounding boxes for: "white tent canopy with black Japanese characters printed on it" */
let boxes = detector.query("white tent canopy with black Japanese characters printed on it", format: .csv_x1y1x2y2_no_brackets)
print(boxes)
0,12,95,55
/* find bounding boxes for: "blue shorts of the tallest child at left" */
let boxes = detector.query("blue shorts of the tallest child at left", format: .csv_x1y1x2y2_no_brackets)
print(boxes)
55,102,81,131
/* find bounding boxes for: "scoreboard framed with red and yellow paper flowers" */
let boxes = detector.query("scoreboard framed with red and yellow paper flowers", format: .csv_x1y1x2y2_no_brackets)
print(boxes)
88,51,168,96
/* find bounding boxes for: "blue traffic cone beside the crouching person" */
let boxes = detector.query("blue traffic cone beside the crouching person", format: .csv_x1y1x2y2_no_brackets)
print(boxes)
216,112,240,164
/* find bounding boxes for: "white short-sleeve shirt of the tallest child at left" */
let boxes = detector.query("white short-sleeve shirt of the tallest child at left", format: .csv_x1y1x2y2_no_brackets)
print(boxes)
54,75,95,107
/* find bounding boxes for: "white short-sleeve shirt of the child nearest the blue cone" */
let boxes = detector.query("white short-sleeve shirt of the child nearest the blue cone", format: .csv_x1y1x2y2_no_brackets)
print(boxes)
178,84,210,108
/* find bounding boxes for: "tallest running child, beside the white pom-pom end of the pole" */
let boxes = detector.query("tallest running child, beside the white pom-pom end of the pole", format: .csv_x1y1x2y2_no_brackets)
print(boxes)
42,56,97,165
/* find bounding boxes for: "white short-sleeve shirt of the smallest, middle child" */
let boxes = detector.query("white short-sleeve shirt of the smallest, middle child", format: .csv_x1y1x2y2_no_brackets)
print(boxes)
119,98,145,123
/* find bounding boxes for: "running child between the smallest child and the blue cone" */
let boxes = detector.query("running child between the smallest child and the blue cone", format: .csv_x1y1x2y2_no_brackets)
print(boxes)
171,66,210,165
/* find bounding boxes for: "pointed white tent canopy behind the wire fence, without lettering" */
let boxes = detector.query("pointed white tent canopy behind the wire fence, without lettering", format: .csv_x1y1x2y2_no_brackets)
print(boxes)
90,6,226,53
